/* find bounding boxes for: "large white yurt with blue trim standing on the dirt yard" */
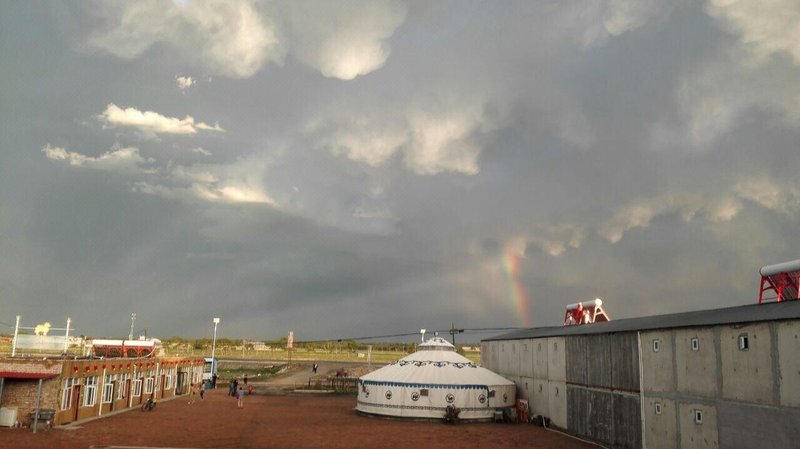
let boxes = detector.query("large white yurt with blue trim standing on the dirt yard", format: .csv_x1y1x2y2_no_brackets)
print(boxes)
356,337,516,419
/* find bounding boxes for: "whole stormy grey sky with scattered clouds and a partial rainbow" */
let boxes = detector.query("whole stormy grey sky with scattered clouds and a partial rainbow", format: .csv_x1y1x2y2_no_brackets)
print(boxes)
0,0,800,341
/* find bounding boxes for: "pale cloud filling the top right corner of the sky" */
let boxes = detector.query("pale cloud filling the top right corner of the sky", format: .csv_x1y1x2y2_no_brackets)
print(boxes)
706,0,800,66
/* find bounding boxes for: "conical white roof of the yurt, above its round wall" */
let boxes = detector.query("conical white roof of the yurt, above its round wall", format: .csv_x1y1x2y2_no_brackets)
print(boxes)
361,337,513,387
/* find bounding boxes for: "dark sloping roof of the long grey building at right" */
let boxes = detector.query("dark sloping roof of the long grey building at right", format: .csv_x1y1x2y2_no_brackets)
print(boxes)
481,300,800,341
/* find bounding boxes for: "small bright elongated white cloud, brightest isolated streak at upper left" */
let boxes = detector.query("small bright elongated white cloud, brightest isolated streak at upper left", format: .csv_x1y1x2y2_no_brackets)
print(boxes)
97,103,225,137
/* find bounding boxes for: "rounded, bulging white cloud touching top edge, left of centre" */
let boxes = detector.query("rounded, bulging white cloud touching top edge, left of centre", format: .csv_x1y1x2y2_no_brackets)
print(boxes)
287,0,406,80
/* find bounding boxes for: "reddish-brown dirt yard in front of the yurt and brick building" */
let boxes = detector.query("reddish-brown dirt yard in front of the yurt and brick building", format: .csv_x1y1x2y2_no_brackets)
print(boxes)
0,388,596,449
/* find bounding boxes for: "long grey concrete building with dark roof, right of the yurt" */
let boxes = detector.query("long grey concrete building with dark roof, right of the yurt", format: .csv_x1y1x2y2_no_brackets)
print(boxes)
481,300,800,449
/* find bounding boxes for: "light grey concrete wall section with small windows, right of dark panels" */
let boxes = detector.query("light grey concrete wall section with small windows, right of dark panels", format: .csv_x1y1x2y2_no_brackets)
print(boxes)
641,320,800,449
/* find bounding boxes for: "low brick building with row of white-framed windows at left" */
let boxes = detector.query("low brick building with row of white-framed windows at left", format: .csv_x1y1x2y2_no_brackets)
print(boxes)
0,357,204,426
